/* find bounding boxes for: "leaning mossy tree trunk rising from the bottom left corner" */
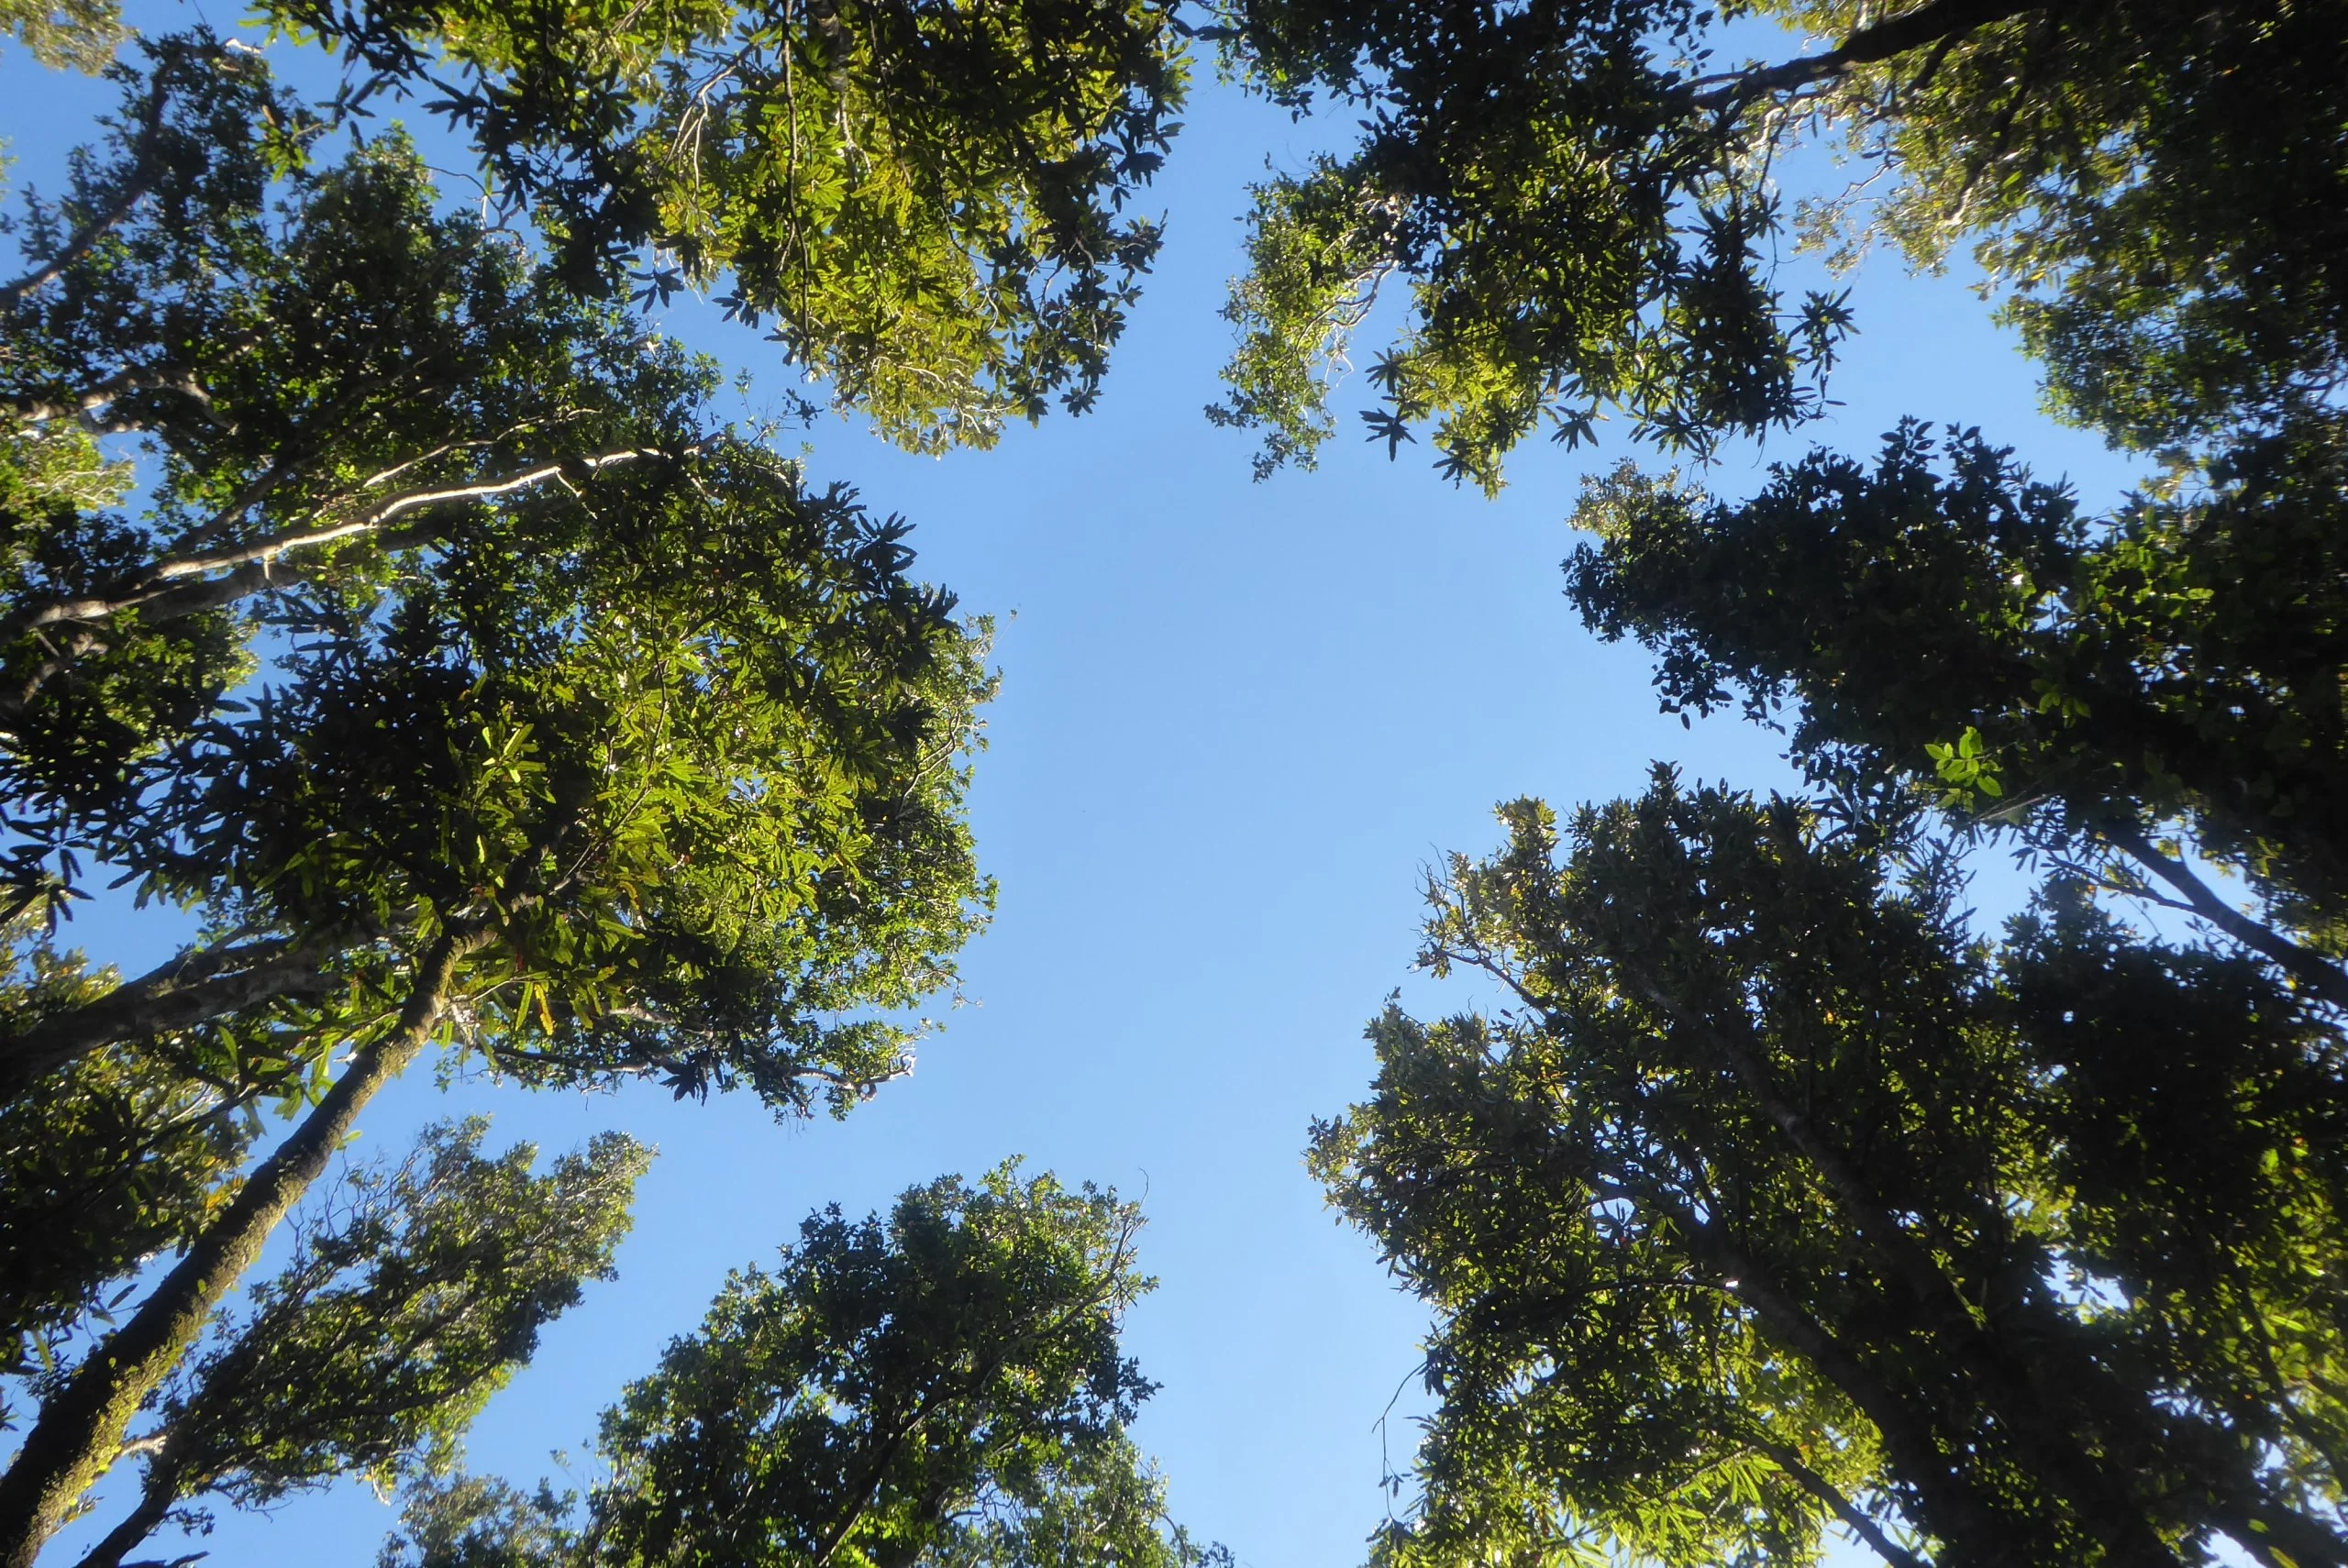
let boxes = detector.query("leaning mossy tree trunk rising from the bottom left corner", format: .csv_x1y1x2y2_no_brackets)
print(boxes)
0,932,486,1568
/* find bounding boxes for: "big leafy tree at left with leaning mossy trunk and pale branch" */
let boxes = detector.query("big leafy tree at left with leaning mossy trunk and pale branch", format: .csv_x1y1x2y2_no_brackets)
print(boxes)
0,35,991,1563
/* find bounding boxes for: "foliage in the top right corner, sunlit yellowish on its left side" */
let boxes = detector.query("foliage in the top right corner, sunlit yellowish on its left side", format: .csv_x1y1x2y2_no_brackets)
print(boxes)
1761,3,2348,448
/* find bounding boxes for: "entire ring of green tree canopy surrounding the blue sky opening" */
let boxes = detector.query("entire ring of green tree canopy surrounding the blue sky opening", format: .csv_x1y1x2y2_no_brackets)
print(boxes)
0,0,2348,1568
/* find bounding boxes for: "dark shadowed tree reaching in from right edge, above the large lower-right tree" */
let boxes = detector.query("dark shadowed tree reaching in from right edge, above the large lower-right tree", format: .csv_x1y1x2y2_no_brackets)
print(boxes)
1568,423,2348,971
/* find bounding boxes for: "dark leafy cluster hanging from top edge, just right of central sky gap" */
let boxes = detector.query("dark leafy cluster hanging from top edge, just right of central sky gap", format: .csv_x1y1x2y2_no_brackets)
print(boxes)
1212,0,1848,491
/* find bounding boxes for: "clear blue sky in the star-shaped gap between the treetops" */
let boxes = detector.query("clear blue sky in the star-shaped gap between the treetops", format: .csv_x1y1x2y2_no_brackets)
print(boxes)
0,21,2127,1568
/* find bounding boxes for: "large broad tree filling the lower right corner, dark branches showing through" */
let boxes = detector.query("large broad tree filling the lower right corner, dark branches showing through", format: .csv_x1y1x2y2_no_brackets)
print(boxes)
1315,772,2348,1568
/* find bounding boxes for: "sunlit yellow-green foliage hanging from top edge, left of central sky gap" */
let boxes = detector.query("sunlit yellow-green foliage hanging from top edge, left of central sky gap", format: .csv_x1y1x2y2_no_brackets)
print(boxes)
260,0,1186,450
